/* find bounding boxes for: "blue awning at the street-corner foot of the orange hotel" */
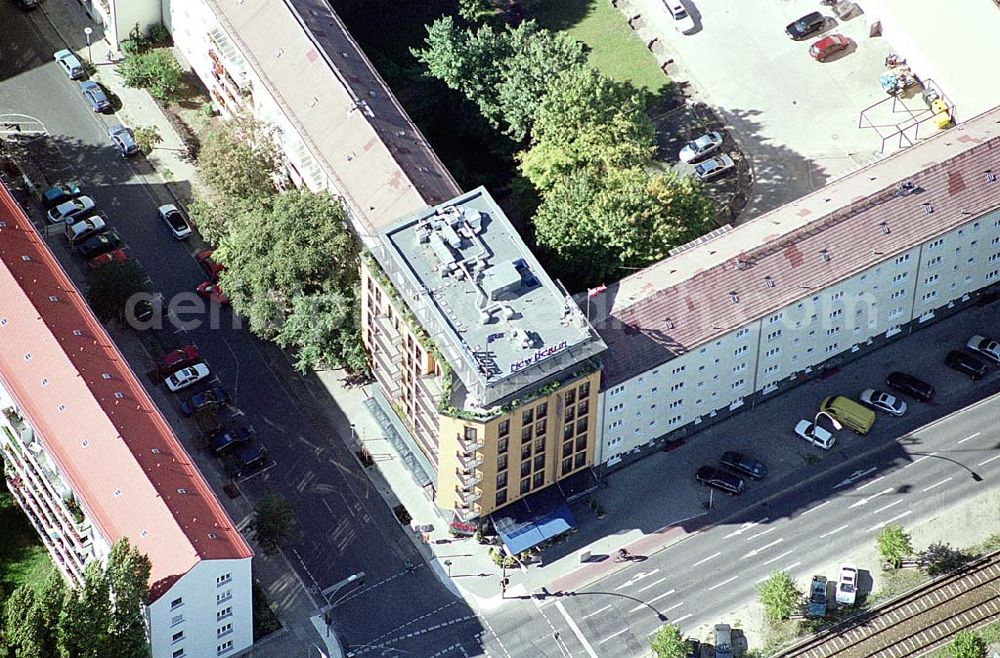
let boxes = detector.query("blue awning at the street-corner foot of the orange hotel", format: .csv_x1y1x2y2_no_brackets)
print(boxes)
491,486,576,555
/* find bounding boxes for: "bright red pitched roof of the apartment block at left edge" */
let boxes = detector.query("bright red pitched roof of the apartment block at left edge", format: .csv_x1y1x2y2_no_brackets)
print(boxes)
0,185,253,597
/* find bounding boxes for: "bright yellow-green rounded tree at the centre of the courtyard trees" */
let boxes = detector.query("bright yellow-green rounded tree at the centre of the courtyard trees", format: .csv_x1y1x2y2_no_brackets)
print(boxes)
518,67,656,193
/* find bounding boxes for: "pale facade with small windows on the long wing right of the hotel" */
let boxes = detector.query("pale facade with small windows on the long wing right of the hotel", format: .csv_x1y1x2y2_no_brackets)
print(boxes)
595,210,1000,466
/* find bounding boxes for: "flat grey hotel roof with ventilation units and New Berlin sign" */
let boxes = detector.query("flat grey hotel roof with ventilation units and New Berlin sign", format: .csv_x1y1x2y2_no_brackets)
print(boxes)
376,187,605,407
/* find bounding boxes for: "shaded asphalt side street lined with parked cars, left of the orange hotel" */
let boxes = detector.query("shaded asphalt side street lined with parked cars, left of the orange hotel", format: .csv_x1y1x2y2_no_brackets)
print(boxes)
0,2,483,655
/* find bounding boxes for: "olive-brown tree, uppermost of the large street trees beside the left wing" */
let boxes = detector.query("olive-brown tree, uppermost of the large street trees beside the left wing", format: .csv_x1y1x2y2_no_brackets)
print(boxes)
198,114,282,201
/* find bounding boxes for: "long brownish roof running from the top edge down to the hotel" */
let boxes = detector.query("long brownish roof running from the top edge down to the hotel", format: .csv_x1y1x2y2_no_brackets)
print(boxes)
208,0,461,233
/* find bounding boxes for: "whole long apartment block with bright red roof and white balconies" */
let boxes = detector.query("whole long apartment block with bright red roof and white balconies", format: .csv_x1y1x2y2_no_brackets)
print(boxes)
0,187,253,658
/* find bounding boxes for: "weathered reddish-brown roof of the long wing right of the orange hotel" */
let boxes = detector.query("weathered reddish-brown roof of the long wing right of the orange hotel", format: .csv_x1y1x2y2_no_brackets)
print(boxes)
590,108,1000,386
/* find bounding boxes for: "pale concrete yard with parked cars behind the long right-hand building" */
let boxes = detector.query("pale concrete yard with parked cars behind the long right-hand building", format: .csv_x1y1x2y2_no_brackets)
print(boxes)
622,0,896,220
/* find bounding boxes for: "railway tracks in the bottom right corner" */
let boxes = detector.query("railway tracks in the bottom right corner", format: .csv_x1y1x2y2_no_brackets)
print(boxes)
778,552,1000,658
